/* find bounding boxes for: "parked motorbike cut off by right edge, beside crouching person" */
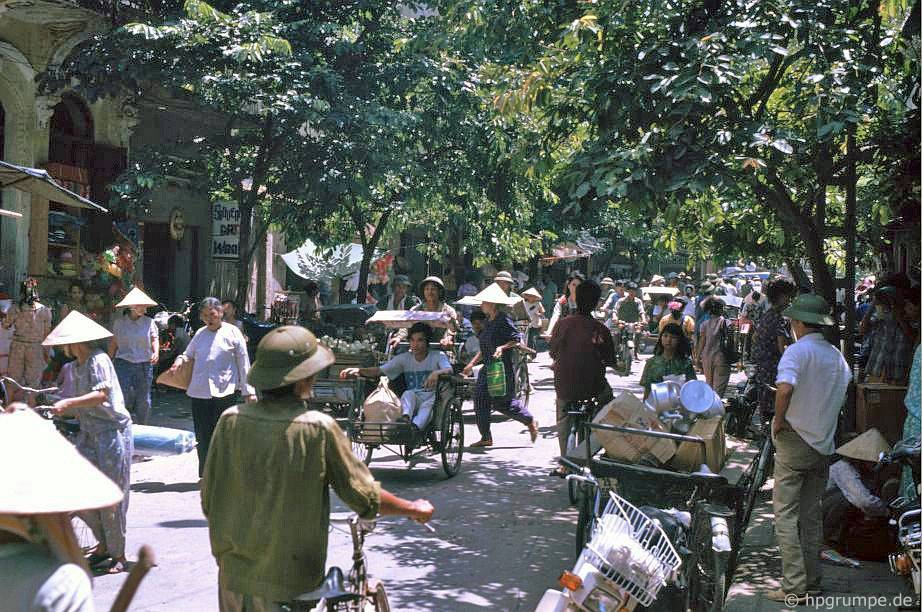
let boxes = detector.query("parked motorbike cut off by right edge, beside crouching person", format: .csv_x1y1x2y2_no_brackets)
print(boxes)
879,437,922,595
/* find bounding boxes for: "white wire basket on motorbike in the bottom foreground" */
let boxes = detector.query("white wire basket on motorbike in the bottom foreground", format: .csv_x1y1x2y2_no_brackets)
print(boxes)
585,492,682,606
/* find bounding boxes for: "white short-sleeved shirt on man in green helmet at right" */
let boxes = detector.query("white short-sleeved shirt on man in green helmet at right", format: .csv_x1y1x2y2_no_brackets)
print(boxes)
775,333,852,455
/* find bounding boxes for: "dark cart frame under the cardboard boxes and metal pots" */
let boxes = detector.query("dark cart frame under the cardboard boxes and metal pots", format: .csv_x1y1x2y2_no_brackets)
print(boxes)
562,423,771,612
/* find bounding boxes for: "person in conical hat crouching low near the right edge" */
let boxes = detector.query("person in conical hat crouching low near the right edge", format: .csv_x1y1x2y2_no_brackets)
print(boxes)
822,429,890,548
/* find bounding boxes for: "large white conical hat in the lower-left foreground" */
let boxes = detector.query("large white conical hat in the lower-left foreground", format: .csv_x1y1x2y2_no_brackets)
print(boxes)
0,408,122,514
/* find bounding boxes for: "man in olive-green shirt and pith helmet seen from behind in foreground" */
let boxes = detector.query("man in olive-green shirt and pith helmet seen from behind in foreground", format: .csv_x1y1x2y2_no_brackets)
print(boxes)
202,326,433,612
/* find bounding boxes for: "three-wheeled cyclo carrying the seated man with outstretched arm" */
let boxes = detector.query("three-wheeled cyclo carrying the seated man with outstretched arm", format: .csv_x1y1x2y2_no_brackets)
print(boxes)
346,310,468,477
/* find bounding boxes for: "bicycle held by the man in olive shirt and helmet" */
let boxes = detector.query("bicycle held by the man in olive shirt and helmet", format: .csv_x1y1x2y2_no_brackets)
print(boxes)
286,512,391,612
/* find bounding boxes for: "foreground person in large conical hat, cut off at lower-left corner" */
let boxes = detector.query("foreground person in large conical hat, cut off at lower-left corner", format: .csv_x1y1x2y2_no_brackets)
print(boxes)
0,404,122,612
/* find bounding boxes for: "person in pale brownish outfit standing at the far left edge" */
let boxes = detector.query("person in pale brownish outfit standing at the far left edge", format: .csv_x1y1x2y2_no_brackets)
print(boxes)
3,278,51,398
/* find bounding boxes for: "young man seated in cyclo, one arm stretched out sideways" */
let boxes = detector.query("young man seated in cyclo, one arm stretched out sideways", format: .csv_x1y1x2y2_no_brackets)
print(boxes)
339,323,453,431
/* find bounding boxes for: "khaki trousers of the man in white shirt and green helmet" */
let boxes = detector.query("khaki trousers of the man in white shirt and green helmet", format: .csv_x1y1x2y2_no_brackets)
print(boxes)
772,428,829,595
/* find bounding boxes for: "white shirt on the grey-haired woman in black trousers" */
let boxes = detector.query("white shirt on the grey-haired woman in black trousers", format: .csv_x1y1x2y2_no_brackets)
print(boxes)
183,321,256,399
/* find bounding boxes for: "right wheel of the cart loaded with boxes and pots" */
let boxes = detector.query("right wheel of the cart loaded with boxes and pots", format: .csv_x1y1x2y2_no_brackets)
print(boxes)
685,512,727,612
